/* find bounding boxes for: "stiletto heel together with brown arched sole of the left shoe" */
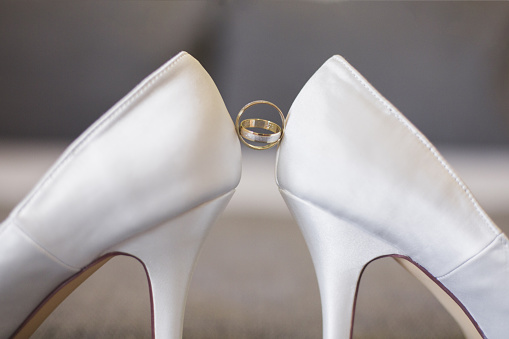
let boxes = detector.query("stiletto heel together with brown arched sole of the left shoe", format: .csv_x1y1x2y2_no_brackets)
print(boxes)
13,191,234,339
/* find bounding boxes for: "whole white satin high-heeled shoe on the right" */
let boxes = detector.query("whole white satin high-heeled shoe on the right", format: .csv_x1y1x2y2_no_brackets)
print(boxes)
276,56,509,339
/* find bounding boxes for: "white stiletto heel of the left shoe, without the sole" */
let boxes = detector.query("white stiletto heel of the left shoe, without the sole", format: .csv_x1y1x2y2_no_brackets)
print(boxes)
112,191,233,338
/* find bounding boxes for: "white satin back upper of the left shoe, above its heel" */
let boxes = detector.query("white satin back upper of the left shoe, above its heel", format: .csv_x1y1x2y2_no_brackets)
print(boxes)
13,53,240,267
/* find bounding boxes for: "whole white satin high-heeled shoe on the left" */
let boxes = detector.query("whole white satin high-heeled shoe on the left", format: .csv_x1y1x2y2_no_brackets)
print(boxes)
0,52,241,338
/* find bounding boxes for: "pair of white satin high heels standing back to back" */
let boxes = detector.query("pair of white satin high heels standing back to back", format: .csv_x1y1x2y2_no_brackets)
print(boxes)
0,52,509,338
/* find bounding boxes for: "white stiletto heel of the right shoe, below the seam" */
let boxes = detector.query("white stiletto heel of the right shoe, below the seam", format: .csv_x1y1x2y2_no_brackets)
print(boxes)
280,190,399,338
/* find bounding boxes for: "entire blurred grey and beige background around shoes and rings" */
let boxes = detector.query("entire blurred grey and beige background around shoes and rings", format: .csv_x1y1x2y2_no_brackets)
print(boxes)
0,0,509,338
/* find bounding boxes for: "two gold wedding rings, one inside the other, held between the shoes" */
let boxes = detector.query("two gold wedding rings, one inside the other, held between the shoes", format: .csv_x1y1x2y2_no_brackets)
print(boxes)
235,100,285,150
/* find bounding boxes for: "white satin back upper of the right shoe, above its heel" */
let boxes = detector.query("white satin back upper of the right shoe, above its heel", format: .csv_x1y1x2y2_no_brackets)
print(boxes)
277,57,500,276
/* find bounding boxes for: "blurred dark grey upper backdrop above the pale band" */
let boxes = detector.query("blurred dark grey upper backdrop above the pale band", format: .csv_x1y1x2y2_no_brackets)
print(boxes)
0,1,509,145
